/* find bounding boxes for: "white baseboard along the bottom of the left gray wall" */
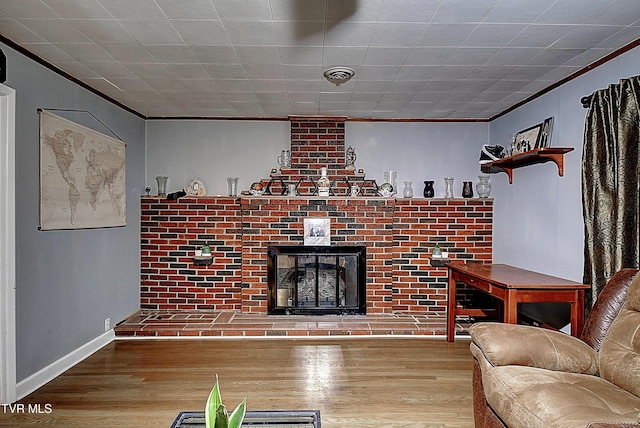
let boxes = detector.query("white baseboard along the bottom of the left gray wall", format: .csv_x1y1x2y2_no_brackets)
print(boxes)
16,329,115,400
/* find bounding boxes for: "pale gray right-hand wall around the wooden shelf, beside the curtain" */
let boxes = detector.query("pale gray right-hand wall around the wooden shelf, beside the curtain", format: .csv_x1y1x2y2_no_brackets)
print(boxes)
489,44,640,281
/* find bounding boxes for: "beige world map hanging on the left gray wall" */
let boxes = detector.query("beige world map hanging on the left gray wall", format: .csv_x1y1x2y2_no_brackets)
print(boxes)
39,110,126,230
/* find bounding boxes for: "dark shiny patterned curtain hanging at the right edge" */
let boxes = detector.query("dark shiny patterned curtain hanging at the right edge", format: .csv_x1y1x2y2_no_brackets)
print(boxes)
582,76,640,303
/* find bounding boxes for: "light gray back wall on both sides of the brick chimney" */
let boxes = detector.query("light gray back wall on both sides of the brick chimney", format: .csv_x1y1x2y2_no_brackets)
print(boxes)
147,120,488,196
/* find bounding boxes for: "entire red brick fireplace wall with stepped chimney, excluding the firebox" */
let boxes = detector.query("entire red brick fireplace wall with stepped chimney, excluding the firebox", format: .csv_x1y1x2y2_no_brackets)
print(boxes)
141,118,493,315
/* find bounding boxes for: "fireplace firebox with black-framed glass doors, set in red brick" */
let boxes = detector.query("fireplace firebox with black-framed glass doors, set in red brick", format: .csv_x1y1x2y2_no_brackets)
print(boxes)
267,245,366,315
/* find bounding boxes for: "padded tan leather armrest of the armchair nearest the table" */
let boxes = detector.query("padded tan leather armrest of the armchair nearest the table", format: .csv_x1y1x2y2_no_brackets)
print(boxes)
469,322,598,375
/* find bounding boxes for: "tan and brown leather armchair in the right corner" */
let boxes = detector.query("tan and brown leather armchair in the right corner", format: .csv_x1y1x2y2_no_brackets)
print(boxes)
470,269,640,428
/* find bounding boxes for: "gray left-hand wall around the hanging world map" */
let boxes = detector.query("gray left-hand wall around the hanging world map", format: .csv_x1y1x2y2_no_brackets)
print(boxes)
0,44,145,381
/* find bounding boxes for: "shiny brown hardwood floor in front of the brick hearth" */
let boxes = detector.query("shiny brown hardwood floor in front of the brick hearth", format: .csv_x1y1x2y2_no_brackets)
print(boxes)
0,337,473,428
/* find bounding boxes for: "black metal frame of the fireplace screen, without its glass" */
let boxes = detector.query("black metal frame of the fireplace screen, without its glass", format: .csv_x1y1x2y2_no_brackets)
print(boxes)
267,245,367,315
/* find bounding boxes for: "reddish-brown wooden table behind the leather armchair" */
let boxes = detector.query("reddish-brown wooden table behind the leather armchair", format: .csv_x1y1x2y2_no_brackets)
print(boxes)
447,262,589,342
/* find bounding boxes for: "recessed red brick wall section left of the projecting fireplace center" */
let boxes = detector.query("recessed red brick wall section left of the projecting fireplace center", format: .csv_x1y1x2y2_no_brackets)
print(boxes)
140,197,242,310
